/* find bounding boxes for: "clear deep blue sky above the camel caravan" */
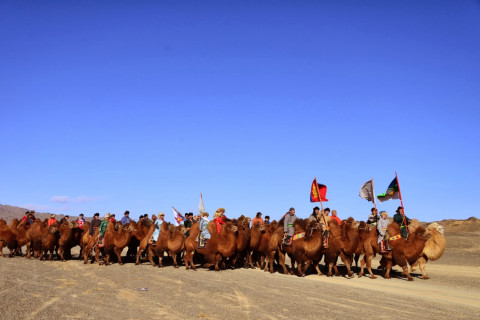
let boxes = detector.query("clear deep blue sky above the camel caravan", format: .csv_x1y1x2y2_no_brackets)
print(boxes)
0,1,480,221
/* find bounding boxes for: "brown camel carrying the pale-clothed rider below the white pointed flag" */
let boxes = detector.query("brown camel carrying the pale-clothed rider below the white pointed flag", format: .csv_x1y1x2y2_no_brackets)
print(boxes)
184,220,238,271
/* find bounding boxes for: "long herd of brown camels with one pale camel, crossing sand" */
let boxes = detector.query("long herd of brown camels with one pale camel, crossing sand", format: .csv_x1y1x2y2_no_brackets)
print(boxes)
0,216,446,280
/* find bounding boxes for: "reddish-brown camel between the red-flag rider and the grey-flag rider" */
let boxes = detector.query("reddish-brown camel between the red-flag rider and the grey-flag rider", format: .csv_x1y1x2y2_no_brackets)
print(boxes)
325,217,359,277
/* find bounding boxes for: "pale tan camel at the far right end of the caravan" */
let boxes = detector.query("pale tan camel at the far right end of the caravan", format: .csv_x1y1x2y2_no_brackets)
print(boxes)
409,222,447,279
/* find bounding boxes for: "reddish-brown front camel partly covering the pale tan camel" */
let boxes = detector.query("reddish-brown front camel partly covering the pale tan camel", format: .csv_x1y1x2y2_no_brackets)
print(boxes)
380,222,430,281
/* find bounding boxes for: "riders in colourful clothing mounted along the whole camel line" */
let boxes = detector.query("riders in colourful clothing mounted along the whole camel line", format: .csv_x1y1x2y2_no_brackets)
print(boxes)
21,206,411,253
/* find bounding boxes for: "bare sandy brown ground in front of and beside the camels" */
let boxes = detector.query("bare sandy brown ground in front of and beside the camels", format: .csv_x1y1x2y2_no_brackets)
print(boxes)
0,233,480,319
